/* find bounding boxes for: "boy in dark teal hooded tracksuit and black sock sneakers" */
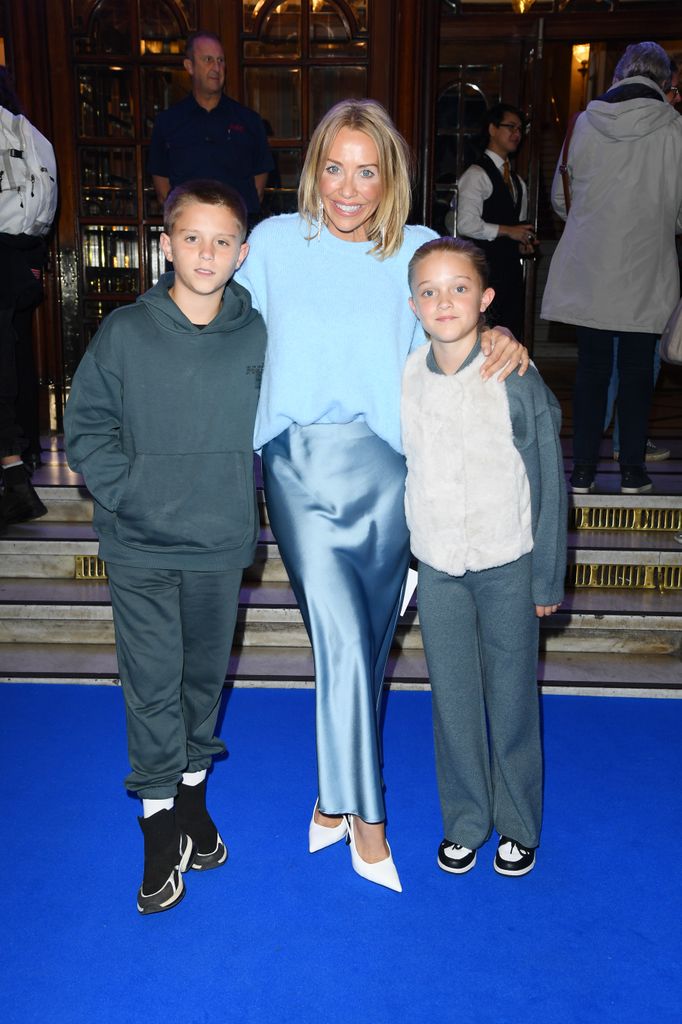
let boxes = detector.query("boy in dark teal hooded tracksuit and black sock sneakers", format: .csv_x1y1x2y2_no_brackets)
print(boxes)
65,181,265,913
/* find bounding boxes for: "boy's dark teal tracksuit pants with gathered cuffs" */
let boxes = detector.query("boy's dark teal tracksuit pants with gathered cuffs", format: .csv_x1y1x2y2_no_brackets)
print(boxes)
106,563,242,799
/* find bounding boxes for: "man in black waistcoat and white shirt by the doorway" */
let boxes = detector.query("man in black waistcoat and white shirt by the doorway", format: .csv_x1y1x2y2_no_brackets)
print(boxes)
457,103,537,338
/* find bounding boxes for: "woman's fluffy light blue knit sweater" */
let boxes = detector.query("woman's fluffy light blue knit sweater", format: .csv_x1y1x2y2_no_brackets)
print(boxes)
236,214,436,452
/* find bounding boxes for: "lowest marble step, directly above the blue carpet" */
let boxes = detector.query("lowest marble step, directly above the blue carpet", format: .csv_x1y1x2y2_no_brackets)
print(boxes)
0,643,682,697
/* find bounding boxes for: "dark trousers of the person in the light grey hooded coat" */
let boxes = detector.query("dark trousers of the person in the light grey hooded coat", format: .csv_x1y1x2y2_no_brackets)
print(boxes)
573,327,657,469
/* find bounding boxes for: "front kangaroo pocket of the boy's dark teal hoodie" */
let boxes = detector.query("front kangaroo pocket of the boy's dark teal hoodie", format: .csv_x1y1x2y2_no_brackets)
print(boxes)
116,452,256,553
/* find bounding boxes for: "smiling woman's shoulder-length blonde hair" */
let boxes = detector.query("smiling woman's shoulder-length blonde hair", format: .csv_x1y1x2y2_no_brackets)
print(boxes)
298,99,412,259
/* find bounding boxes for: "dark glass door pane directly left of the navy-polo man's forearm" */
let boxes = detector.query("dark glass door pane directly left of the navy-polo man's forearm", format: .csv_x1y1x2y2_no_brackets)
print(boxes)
80,146,137,217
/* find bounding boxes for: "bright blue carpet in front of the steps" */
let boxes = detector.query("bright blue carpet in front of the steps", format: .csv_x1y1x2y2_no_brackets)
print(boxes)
0,685,682,1024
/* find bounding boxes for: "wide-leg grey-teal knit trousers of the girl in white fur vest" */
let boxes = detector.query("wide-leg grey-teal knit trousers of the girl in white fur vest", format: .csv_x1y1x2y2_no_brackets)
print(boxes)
418,555,543,850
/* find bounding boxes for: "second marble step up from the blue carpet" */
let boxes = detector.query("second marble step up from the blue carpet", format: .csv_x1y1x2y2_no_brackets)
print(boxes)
0,579,682,656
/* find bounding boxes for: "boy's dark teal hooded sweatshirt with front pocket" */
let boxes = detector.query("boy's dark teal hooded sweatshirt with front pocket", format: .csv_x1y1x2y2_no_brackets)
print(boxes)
65,273,265,571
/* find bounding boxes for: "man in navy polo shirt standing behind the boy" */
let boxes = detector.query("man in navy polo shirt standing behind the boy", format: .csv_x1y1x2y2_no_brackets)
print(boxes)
148,31,274,222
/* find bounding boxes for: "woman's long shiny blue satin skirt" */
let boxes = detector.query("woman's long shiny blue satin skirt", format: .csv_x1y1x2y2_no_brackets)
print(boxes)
262,421,410,822
